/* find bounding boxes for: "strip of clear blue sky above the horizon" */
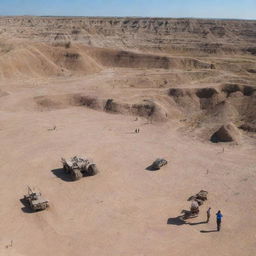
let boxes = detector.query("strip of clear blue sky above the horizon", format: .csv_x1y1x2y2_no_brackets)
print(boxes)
0,0,256,19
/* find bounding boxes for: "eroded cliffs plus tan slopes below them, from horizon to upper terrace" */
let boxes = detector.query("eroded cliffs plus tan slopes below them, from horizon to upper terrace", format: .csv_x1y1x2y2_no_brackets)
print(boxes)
0,17,256,80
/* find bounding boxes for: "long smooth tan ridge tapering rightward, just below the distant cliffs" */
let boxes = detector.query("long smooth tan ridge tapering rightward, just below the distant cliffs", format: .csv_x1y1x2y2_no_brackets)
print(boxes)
0,41,214,79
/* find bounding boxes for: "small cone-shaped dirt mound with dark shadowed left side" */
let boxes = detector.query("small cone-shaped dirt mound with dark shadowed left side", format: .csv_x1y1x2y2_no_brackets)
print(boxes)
211,123,240,143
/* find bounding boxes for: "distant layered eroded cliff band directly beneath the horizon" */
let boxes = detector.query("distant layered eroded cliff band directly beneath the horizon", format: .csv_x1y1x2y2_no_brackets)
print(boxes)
0,17,256,55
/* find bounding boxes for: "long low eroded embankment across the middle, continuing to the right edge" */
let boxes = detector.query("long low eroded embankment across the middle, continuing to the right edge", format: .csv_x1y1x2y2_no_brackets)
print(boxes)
35,84,256,127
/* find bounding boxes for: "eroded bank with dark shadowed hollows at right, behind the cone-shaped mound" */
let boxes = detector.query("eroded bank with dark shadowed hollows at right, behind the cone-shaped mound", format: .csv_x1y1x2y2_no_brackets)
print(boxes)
168,84,256,122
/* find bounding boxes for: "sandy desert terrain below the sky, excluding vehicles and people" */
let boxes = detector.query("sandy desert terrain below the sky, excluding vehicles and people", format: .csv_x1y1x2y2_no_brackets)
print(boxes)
0,17,256,256
